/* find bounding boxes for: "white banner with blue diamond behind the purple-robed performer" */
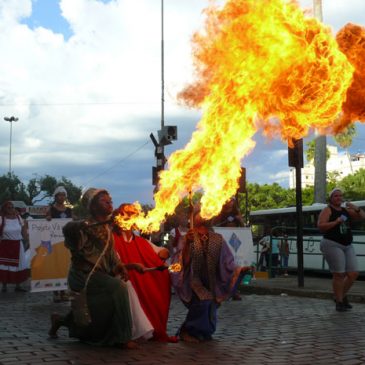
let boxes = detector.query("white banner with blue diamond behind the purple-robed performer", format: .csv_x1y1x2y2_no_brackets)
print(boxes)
213,227,256,266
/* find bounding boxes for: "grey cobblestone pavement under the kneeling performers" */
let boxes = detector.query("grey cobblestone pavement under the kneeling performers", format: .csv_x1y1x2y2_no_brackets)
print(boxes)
0,292,365,365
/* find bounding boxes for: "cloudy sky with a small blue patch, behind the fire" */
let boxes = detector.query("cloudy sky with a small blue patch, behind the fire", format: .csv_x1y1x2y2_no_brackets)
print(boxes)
0,0,365,205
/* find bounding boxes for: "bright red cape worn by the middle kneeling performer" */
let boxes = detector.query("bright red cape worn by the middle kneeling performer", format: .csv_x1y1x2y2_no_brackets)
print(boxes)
114,233,171,341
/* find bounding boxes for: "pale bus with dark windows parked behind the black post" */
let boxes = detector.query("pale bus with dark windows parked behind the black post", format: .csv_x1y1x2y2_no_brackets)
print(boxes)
250,200,365,275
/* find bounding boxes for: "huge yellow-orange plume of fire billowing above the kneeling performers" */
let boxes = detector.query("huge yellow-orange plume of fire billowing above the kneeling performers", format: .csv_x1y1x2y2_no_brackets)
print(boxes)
117,0,365,231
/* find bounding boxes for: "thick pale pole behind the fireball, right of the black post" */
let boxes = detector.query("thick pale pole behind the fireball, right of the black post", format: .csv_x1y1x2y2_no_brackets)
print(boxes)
313,0,327,203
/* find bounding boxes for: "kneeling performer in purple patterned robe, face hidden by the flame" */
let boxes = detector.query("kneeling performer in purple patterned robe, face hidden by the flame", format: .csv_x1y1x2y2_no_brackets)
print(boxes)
171,208,251,342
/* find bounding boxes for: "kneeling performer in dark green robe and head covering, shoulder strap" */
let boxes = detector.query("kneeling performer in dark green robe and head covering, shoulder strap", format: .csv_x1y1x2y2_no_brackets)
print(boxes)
49,188,153,348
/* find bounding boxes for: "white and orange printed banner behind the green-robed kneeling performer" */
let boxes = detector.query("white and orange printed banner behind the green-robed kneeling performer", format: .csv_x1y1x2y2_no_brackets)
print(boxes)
28,218,71,292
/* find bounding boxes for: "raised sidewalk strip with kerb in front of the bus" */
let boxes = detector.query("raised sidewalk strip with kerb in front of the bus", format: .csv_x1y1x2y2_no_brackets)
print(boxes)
240,275,365,303
